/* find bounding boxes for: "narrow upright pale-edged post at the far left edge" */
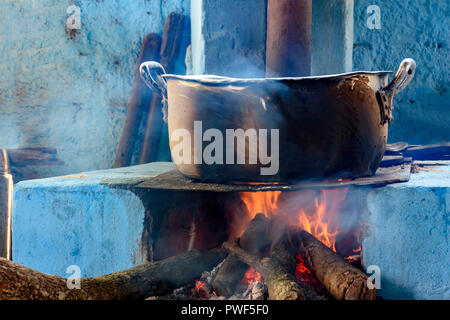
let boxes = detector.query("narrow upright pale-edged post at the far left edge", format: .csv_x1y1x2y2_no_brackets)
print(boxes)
0,148,13,260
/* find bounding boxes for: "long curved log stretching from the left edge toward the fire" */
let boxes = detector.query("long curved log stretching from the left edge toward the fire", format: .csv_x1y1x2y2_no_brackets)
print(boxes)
0,250,227,300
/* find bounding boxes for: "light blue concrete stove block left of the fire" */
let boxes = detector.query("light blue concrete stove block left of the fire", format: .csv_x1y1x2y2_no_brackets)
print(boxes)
12,163,174,277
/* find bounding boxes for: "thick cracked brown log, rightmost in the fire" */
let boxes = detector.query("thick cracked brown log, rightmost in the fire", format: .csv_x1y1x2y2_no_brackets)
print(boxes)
296,228,376,300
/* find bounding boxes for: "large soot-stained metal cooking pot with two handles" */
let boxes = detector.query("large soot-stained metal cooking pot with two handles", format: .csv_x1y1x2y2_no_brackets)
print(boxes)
140,59,416,182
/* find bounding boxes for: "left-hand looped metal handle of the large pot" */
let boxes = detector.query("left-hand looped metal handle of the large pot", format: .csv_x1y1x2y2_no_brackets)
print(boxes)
139,61,167,123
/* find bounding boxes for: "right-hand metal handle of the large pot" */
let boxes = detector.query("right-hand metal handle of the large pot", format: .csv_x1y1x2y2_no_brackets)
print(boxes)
377,58,416,125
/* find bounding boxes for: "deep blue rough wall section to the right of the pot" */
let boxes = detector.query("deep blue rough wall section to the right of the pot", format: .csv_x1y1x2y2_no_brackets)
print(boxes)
353,0,450,144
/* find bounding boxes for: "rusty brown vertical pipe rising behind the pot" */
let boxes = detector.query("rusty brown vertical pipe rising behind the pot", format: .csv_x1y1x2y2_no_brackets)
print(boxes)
266,0,312,77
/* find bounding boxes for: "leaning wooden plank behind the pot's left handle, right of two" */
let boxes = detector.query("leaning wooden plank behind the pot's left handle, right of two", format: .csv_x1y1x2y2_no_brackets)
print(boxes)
114,33,161,168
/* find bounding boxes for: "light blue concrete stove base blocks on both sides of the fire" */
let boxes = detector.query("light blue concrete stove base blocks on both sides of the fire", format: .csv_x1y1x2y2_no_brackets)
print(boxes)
12,161,450,299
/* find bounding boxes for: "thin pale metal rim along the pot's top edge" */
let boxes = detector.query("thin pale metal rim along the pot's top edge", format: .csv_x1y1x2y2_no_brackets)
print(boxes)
161,71,393,85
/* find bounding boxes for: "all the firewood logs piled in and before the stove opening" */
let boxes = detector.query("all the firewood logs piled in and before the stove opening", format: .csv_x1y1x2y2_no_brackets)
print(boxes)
0,210,376,300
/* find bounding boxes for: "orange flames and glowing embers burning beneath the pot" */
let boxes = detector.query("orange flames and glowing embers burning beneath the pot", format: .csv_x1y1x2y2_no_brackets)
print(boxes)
237,188,361,290
